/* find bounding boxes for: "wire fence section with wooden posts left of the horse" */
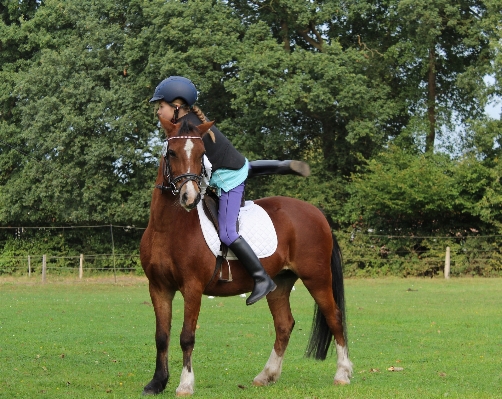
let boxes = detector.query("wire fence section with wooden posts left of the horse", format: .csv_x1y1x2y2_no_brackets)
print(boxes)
0,224,145,281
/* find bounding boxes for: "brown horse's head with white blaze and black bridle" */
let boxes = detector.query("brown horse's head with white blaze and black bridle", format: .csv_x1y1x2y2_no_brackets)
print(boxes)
159,118,214,211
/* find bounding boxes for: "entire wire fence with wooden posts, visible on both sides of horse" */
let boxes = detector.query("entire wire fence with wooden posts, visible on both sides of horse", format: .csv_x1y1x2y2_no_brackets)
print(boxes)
0,225,502,278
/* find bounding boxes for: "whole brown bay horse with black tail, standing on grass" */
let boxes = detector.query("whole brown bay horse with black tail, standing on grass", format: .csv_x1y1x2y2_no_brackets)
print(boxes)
140,118,352,396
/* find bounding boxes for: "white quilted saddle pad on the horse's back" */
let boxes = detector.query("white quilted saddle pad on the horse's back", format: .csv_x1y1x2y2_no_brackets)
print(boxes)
197,201,277,260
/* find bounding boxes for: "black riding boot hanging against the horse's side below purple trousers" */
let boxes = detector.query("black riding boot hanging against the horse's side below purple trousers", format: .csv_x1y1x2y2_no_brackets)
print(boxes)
228,237,277,305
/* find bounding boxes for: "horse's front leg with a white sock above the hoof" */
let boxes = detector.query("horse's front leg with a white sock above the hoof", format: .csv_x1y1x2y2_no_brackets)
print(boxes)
176,291,202,396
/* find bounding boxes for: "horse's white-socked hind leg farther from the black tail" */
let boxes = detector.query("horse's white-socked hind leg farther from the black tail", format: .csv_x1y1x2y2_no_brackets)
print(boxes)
253,272,298,386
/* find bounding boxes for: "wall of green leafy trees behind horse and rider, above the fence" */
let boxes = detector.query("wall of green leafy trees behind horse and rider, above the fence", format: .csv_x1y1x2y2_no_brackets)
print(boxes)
0,0,502,241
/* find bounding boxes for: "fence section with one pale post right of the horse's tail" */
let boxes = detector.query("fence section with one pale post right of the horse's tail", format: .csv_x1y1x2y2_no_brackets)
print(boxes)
337,232,502,277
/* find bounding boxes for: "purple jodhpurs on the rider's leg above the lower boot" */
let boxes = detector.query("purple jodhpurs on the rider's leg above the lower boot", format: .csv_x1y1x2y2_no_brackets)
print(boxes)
218,183,245,246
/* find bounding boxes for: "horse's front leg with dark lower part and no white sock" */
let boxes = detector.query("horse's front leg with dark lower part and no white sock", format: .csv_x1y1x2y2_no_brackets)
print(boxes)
143,283,176,395
